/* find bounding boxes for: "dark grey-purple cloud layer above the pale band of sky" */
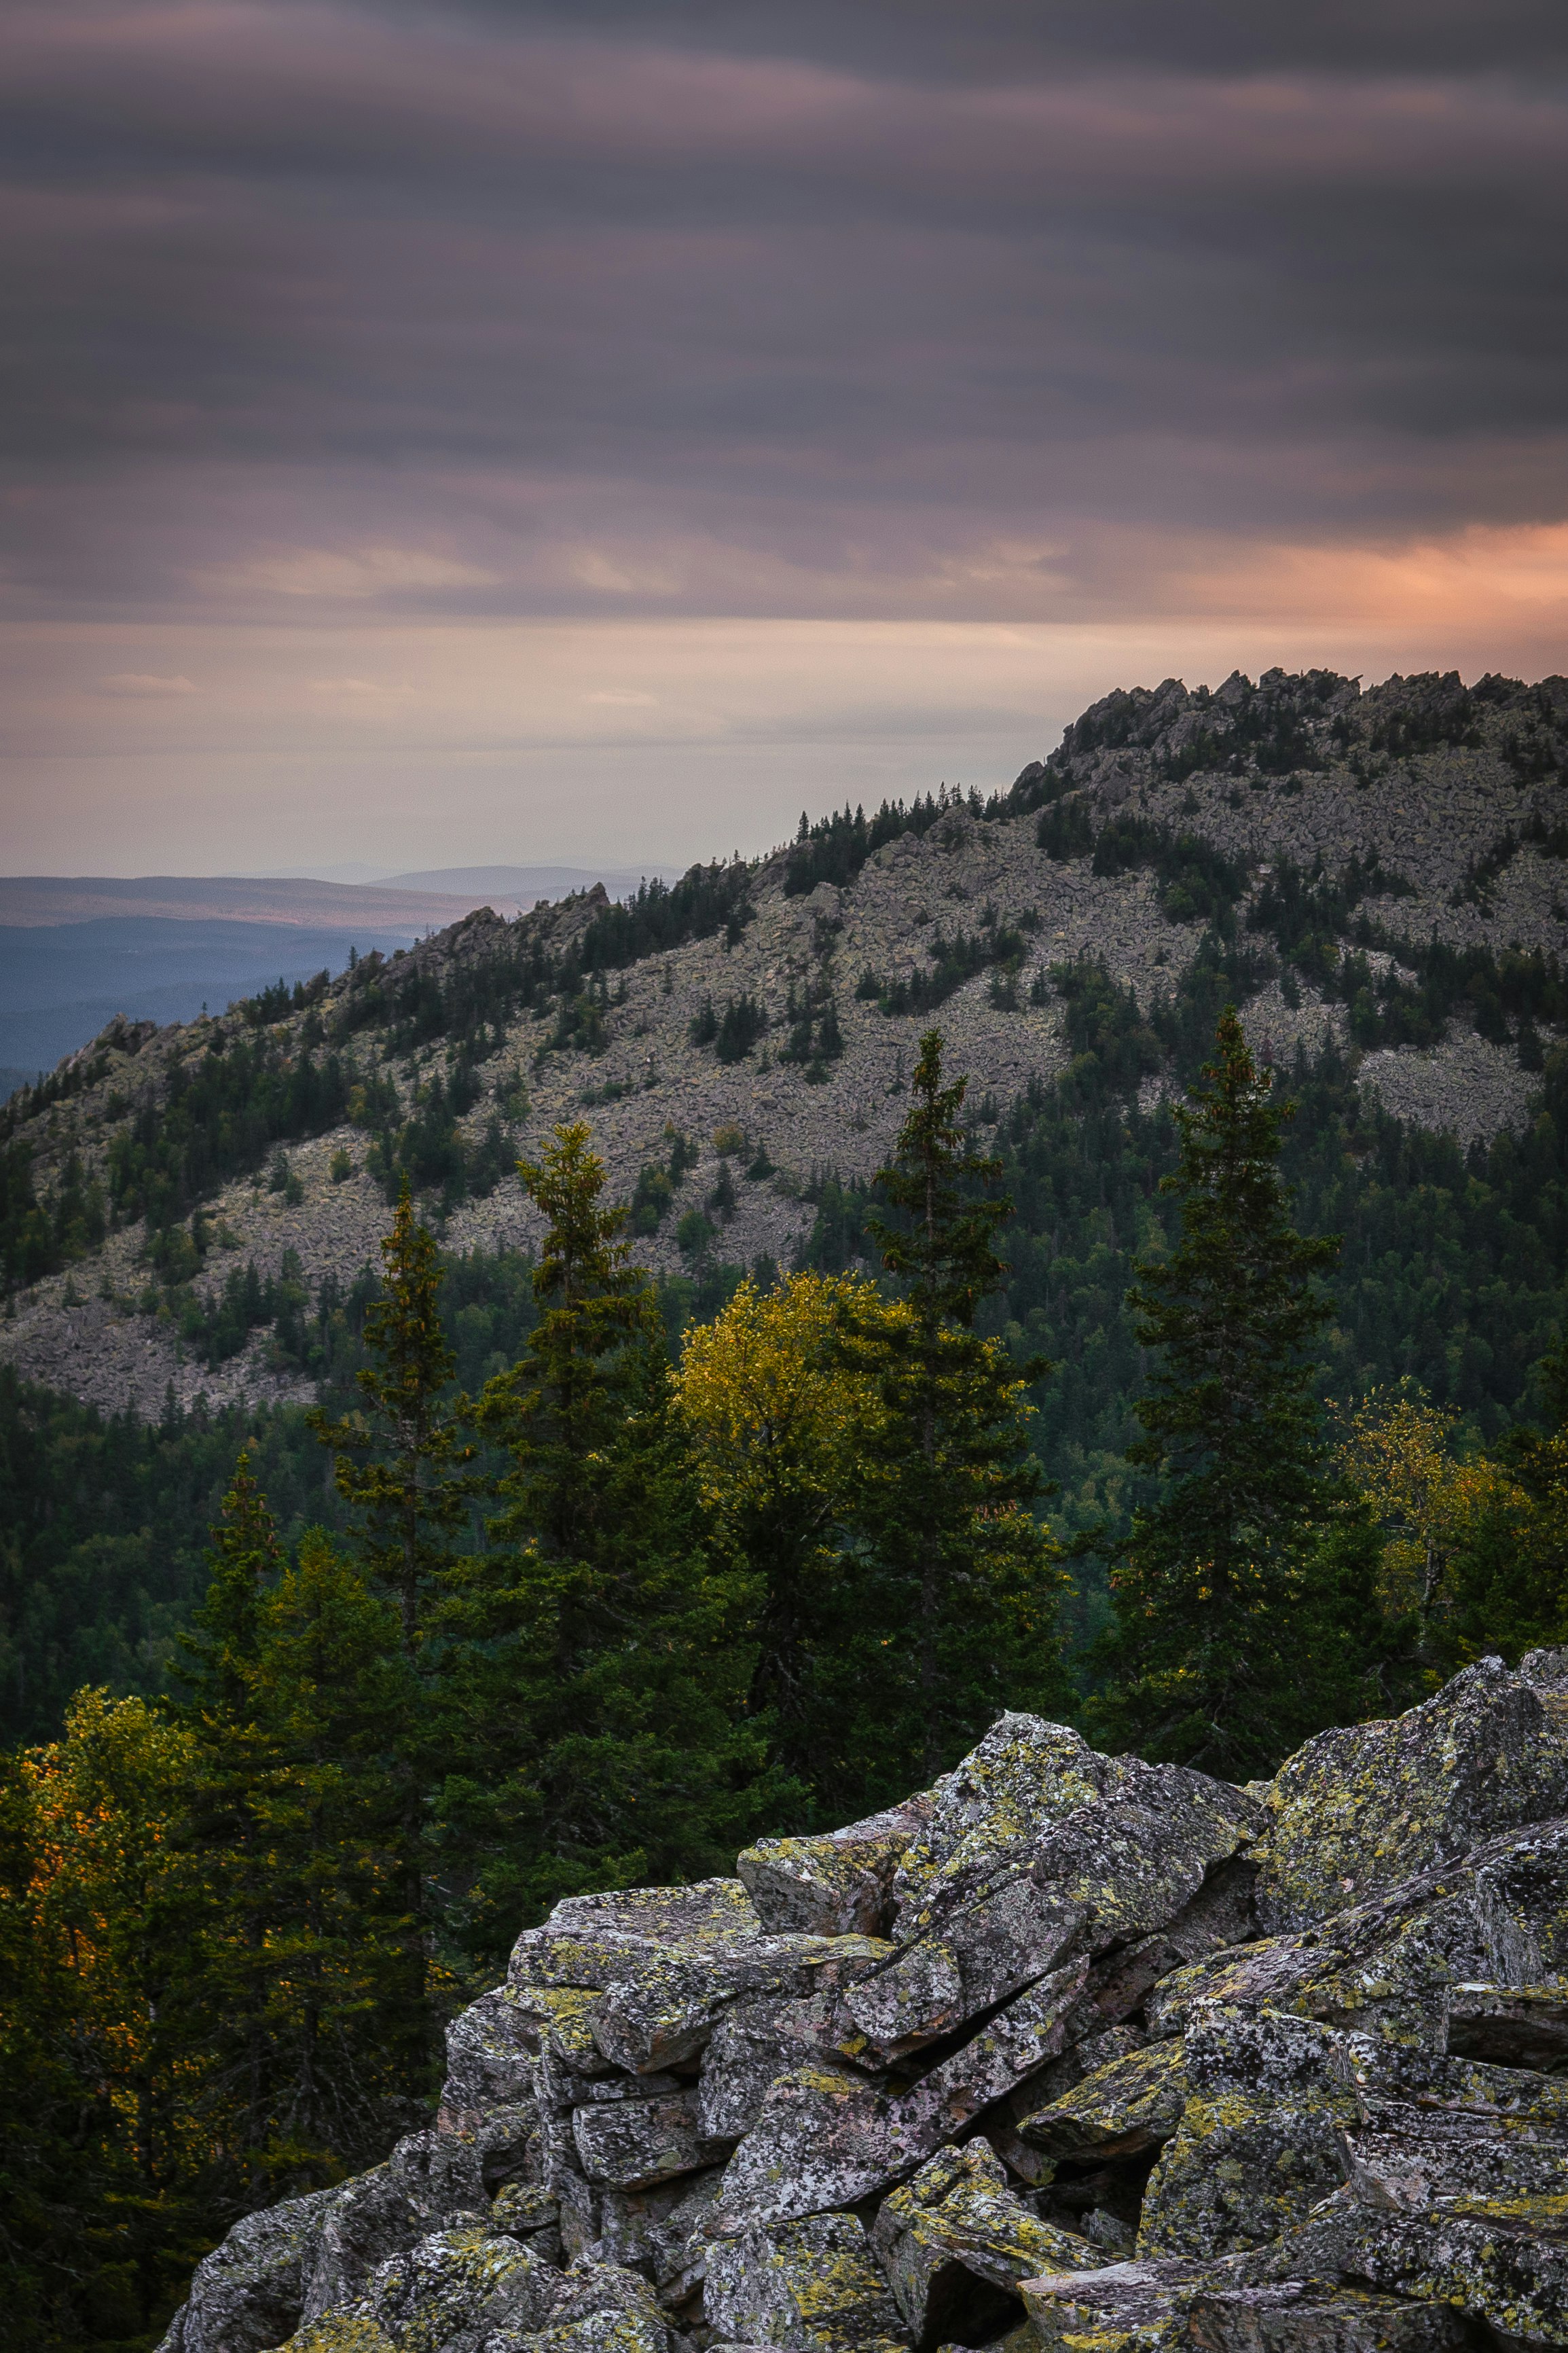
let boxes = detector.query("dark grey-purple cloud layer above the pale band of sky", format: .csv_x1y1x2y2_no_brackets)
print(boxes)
0,0,1568,612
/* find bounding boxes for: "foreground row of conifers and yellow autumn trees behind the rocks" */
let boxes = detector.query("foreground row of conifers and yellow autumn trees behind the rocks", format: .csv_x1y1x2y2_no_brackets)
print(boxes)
0,1009,1568,2346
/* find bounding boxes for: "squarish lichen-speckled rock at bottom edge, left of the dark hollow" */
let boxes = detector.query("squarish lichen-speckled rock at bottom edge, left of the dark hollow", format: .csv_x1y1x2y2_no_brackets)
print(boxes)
703,2214,907,2353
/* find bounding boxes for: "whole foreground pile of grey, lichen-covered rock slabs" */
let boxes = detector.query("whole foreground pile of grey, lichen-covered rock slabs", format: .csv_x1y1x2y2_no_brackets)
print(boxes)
162,1652,1568,2353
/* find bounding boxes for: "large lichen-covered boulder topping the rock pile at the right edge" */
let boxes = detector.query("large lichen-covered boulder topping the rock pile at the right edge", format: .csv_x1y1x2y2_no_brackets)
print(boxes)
1260,1659,1568,1929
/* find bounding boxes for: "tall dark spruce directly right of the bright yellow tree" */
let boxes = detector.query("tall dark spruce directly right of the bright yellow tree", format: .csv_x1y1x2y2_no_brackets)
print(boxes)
849,1030,1070,1802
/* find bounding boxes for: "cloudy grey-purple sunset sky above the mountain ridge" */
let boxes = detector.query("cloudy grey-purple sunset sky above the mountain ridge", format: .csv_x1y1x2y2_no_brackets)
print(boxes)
0,0,1568,873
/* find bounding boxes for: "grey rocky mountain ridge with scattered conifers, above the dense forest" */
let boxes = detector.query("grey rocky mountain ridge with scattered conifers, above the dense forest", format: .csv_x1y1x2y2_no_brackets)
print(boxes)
0,670,1568,1412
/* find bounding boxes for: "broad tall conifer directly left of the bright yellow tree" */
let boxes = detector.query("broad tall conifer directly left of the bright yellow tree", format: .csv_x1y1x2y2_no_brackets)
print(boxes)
444,1122,762,1953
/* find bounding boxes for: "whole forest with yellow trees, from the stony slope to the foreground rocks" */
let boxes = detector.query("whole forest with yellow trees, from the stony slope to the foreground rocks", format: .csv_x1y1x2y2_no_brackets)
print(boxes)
0,1002,1568,2346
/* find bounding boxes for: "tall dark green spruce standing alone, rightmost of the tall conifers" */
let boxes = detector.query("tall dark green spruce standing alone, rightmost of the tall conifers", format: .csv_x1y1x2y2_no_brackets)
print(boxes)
1091,1007,1359,1779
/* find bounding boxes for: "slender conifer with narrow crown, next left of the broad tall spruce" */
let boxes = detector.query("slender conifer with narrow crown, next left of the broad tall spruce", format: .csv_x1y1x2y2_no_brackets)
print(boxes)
310,1179,477,2059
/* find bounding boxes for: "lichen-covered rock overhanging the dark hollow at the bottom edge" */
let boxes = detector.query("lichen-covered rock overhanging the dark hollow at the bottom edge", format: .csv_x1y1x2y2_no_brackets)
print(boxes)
872,2141,1100,2353
